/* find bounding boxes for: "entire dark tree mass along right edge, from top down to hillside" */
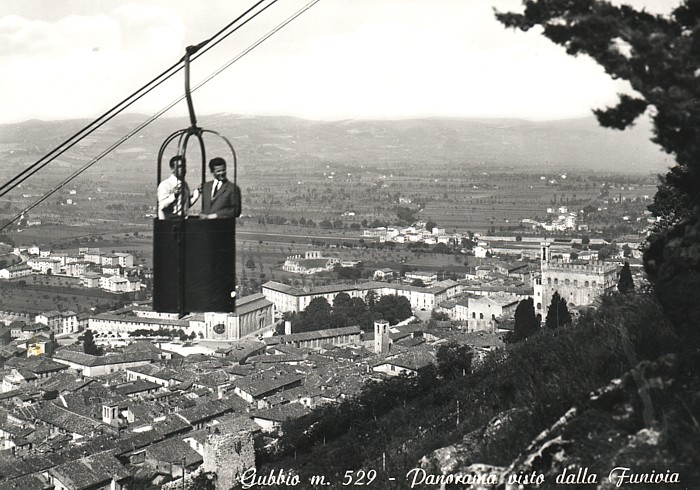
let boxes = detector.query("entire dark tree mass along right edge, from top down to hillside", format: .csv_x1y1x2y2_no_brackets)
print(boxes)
497,0,700,345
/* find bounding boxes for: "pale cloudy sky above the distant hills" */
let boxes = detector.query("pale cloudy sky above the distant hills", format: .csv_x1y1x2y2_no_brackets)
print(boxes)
0,0,679,123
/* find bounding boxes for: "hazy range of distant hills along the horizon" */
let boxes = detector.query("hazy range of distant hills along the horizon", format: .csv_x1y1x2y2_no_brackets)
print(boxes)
0,114,673,180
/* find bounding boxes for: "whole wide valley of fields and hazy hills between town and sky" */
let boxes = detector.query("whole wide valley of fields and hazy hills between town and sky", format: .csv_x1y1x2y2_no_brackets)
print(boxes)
0,115,668,309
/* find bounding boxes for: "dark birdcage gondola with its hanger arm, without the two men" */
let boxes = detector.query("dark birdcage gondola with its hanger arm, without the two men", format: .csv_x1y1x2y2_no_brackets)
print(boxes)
153,46,238,317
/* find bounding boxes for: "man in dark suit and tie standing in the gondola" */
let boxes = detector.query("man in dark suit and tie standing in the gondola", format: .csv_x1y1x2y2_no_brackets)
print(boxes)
201,157,241,219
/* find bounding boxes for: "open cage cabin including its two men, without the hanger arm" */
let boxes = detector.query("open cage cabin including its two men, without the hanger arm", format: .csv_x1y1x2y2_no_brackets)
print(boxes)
153,128,241,317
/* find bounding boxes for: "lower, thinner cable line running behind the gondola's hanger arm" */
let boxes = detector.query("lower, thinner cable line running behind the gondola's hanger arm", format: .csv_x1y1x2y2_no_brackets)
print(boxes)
0,0,321,231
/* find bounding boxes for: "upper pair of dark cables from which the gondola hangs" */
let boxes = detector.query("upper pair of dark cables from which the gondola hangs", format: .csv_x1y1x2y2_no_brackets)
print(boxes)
0,0,278,197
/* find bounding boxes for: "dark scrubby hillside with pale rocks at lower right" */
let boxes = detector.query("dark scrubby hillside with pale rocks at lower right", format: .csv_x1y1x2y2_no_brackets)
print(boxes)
258,293,700,489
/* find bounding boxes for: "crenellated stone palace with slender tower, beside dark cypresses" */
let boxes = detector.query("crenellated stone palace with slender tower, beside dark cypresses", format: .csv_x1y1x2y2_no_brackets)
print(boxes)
534,242,617,320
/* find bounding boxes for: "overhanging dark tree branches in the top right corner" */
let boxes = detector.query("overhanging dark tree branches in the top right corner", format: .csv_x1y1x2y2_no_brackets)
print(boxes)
496,0,700,205
